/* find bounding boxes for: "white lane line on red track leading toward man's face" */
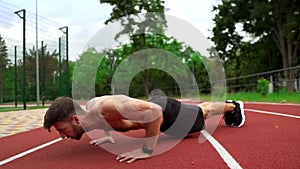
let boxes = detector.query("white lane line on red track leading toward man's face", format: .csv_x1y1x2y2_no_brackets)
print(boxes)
0,138,62,166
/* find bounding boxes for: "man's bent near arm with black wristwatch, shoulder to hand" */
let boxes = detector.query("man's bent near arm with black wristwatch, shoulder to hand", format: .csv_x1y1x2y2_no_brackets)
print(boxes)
101,95,163,163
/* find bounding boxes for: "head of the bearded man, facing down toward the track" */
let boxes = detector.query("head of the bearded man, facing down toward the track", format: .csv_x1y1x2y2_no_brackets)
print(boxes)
44,97,85,140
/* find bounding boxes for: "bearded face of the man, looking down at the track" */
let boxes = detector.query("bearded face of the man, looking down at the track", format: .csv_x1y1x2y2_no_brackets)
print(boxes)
53,121,84,140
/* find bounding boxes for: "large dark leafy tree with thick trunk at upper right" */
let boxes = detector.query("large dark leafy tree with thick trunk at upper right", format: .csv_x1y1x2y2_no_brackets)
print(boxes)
212,0,300,91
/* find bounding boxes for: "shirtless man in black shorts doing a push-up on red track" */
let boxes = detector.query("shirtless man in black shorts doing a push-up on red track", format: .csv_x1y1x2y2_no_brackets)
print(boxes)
44,95,245,163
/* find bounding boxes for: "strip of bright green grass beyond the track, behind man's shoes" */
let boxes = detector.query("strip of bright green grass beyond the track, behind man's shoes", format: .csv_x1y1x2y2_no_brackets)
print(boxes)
200,92,300,104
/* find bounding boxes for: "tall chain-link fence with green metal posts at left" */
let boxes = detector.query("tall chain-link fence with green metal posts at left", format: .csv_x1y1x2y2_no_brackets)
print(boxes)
0,1,68,107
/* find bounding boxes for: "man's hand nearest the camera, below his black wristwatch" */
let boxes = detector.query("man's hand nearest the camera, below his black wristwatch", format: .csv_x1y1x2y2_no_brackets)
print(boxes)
116,149,151,163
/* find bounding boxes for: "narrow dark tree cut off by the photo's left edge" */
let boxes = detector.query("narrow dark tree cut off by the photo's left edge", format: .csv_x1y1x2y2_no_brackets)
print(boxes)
0,35,9,103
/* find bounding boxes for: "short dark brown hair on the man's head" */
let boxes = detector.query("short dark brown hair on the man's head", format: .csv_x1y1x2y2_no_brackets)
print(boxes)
44,97,84,132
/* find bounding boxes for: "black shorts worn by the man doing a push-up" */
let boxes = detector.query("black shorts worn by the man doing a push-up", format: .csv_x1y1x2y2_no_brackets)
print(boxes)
150,97,204,136
